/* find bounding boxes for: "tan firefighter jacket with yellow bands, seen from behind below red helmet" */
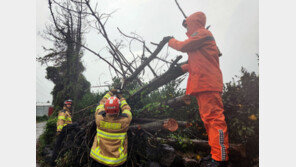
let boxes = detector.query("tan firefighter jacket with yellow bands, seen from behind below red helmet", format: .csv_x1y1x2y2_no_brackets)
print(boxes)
90,92,132,166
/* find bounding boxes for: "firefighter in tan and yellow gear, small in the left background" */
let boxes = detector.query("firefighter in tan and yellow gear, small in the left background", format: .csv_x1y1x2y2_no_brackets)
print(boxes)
57,99,72,134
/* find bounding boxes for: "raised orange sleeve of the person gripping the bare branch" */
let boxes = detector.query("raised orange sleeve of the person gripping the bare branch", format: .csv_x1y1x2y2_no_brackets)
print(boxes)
169,31,214,52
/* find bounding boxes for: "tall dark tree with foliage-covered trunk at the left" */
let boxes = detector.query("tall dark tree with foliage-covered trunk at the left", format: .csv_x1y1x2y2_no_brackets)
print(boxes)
37,7,90,108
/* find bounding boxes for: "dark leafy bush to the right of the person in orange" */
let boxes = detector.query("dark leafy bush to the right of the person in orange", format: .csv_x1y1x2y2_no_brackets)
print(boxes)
222,68,259,143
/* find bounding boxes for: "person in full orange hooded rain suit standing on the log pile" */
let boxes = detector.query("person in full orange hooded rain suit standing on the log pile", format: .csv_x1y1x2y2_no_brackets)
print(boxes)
169,12,229,166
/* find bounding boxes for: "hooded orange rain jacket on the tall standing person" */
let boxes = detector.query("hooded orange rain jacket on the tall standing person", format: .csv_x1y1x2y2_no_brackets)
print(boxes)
169,12,223,95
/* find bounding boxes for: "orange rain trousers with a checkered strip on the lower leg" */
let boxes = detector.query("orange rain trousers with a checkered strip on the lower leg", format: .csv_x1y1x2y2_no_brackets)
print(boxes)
196,92,229,161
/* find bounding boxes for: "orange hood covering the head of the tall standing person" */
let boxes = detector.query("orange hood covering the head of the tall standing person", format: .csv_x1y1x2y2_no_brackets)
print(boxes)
186,12,206,37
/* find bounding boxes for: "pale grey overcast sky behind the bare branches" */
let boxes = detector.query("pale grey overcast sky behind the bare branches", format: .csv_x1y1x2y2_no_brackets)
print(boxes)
36,0,259,103
